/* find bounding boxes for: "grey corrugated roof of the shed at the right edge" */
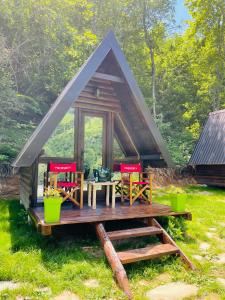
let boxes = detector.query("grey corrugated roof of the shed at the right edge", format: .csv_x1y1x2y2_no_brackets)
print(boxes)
189,109,225,165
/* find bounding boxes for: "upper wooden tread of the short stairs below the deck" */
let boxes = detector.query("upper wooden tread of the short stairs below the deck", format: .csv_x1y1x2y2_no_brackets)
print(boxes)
107,226,162,241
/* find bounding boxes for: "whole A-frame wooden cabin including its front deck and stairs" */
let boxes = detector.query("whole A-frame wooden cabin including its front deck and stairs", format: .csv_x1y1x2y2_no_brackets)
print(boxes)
13,32,193,296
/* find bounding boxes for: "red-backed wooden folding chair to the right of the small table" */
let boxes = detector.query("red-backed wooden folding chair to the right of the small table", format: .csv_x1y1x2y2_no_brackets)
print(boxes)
120,163,152,205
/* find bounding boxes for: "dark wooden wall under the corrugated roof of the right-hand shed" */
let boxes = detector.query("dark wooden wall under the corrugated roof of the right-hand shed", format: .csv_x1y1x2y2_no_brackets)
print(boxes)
194,165,225,187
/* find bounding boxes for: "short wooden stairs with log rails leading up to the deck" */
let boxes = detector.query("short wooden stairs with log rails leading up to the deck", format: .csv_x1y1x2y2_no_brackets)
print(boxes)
95,218,195,299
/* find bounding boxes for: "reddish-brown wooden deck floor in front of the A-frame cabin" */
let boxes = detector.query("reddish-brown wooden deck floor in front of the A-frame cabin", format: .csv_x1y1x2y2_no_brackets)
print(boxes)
29,202,191,234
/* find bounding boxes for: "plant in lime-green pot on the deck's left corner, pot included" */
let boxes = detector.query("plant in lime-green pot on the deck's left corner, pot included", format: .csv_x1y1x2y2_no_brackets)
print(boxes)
44,188,63,223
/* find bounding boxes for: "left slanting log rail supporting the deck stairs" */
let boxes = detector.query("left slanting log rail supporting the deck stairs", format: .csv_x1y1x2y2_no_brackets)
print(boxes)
95,223,133,299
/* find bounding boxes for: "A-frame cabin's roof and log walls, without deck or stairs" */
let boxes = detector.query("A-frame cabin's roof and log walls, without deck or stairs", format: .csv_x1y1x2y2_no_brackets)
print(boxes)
13,32,172,208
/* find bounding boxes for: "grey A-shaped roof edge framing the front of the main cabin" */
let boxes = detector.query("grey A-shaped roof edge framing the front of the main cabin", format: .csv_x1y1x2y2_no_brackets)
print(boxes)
13,31,172,167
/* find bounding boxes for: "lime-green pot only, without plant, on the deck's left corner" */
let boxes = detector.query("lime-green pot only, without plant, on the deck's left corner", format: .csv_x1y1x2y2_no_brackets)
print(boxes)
44,197,62,223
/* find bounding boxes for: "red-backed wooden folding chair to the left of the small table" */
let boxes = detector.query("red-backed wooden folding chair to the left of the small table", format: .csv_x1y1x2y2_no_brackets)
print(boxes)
45,162,84,208
